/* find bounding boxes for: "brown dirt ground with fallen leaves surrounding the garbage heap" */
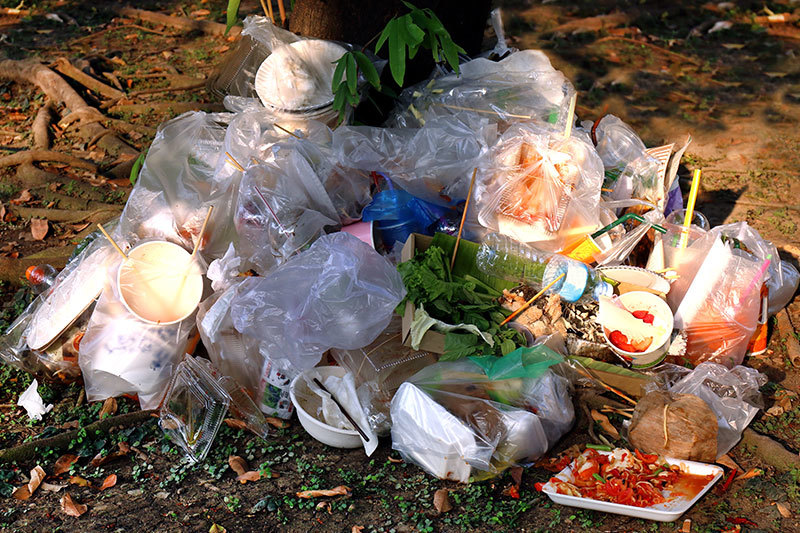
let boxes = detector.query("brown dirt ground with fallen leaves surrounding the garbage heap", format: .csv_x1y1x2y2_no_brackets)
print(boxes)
0,0,800,532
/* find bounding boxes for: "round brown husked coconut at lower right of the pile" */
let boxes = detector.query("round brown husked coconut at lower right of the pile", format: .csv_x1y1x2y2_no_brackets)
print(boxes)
628,391,717,462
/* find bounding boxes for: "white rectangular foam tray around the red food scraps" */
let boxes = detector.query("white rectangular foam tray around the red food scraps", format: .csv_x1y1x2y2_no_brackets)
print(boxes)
542,452,722,522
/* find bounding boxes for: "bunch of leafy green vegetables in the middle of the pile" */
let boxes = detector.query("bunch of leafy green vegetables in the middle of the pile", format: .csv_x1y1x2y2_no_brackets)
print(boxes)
397,245,524,360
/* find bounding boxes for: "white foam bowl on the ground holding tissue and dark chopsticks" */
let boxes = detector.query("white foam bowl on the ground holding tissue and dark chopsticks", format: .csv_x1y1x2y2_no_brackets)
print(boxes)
289,366,362,448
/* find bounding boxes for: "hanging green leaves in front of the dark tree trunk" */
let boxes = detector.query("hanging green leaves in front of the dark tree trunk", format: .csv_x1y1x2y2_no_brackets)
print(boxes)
331,2,466,120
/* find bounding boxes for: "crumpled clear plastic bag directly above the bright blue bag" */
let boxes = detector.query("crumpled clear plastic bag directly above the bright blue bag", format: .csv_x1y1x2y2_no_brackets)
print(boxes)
332,117,497,206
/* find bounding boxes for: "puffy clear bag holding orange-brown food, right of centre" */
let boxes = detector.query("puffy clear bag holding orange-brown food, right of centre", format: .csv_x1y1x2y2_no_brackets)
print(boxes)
478,124,603,252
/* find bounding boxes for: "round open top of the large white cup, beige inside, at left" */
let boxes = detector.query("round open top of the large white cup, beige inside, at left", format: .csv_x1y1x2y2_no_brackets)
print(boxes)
117,241,203,325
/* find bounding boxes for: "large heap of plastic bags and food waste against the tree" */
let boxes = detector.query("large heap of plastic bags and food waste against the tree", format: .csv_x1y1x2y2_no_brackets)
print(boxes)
0,12,800,516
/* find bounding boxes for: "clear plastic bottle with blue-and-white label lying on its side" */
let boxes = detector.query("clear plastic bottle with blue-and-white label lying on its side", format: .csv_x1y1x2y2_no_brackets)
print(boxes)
475,233,613,302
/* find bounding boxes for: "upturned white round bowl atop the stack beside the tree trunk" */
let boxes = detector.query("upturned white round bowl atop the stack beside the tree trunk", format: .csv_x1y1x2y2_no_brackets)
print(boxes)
255,39,347,113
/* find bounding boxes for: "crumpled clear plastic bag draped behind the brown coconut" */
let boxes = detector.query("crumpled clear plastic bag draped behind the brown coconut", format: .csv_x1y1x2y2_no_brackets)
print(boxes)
643,362,767,458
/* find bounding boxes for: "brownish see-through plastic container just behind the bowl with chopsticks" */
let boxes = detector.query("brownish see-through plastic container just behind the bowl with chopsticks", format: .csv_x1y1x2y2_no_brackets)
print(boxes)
331,315,438,436
